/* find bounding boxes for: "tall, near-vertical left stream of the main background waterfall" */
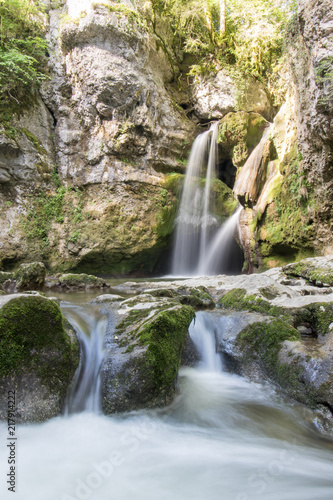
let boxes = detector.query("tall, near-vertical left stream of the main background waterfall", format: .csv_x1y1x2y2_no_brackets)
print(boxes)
172,122,238,276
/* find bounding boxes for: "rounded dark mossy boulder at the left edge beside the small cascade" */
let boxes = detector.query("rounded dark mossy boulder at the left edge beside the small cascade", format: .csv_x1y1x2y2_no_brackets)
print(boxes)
0,294,80,422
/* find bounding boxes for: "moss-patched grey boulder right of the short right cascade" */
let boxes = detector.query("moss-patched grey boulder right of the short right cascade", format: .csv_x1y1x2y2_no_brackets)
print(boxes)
218,286,333,408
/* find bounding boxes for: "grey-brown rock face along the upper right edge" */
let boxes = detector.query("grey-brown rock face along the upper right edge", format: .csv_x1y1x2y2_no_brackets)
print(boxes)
290,0,333,254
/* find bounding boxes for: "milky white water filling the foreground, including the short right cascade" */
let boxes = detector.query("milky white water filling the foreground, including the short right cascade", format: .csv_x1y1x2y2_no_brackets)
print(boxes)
0,305,333,500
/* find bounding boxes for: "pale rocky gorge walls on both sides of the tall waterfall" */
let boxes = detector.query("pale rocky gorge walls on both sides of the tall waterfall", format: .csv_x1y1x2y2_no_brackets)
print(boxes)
0,0,333,275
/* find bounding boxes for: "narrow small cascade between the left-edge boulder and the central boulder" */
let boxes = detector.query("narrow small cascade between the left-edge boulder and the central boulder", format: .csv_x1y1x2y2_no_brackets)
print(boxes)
62,305,107,414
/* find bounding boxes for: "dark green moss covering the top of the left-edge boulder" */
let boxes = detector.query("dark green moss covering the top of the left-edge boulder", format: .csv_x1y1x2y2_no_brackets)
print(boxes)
0,296,78,391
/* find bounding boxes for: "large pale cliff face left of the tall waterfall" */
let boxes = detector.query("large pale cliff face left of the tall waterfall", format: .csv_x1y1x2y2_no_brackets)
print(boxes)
0,0,196,275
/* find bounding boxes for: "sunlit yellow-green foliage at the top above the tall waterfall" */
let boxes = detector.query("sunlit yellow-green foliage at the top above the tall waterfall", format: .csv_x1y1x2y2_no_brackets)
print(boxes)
146,0,296,99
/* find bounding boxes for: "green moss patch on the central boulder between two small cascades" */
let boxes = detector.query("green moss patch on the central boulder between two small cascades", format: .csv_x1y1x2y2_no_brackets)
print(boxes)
138,306,194,389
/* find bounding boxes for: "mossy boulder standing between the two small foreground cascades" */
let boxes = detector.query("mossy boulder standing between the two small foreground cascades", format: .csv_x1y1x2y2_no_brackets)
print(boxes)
102,294,194,414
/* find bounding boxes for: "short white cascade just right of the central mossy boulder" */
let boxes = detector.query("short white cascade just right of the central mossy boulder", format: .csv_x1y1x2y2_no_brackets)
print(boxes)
189,311,223,372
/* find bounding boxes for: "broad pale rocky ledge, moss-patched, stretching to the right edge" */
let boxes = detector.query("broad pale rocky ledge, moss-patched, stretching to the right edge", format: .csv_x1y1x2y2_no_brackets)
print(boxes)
111,256,333,420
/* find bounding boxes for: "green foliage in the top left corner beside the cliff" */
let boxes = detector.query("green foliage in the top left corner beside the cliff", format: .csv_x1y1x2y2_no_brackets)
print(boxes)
0,0,47,120
